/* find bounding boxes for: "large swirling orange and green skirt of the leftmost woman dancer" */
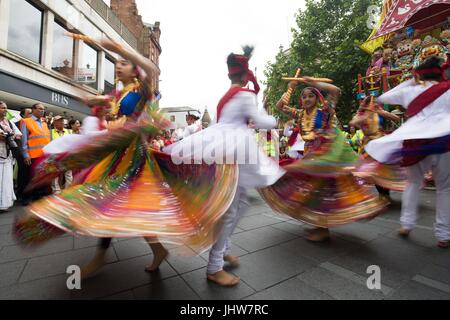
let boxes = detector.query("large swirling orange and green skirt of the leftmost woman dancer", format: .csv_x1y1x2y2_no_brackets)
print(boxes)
16,119,239,250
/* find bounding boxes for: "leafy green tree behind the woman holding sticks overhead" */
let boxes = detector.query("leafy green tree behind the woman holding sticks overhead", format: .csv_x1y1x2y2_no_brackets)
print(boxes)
265,0,381,123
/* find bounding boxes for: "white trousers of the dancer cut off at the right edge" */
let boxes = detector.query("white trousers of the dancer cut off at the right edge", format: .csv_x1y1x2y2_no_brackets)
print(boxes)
400,152,450,241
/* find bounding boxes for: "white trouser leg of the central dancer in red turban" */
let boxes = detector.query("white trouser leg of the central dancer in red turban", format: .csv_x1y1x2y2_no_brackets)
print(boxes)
206,187,248,274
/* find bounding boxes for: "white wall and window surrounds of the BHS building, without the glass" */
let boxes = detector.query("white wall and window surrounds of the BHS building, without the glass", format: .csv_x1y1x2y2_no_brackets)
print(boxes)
0,0,138,105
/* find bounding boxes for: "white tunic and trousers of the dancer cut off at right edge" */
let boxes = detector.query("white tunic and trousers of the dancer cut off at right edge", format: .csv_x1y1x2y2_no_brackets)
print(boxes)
366,58,450,248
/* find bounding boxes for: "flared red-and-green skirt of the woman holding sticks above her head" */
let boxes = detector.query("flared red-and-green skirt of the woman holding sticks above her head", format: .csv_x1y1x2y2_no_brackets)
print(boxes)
258,132,388,228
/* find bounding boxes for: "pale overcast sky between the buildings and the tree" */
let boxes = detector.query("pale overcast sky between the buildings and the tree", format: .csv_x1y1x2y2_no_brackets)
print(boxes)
131,0,304,116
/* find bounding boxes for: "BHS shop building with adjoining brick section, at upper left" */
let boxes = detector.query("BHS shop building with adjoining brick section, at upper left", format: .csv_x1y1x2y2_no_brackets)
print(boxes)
0,0,161,119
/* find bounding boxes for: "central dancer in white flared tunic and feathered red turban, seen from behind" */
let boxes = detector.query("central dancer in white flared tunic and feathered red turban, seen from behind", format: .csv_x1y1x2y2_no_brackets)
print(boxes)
165,47,284,286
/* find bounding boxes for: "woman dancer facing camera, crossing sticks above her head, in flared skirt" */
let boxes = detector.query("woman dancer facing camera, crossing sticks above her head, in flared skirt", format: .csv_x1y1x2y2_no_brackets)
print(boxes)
259,77,386,241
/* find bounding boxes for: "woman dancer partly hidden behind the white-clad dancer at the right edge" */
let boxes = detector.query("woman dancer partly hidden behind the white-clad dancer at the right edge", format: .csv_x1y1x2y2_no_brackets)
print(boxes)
350,96,406,196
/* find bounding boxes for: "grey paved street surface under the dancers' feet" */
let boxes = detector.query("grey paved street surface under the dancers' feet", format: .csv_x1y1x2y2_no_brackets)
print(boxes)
0,191,450,300
